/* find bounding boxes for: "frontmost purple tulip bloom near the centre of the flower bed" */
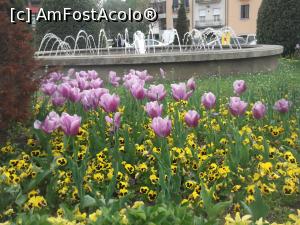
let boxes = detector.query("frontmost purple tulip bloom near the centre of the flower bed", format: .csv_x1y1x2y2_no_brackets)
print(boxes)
151,117,172,137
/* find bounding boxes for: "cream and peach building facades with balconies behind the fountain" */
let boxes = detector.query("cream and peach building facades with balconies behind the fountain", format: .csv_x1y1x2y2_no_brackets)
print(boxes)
152,0,262,35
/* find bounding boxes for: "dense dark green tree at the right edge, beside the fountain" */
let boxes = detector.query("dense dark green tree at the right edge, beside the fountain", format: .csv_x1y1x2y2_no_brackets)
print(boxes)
257,0,300,56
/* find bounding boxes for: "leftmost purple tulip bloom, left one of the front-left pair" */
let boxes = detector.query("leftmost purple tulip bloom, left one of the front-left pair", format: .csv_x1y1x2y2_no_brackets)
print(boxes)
34,111,60,134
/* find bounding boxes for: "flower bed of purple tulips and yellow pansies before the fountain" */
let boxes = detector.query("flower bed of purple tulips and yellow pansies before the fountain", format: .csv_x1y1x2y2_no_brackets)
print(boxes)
0,69,300,224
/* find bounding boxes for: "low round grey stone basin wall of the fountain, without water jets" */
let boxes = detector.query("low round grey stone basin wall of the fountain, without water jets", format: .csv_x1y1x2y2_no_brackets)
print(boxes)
36,45,283,80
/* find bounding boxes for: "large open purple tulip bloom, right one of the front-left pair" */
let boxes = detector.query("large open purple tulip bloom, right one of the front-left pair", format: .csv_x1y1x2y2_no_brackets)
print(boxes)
60,112,81,136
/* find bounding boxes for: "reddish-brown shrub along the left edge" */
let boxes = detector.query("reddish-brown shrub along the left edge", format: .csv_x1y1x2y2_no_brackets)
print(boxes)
0,0,37,130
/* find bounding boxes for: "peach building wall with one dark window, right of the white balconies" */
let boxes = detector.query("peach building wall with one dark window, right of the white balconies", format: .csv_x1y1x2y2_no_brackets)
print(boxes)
226,0,262,35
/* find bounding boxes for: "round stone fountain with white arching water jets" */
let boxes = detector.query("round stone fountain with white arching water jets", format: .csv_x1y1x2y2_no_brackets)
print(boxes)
35,27,283,80
